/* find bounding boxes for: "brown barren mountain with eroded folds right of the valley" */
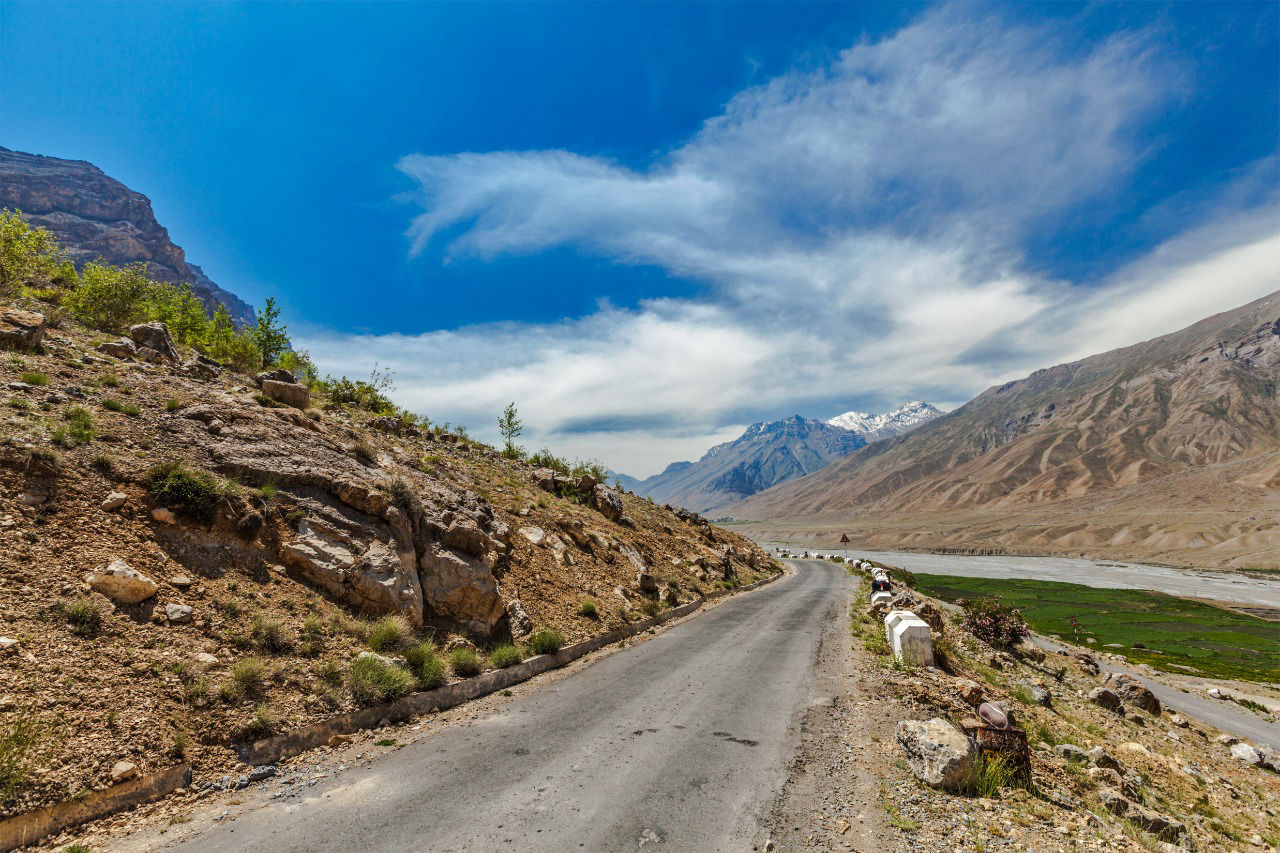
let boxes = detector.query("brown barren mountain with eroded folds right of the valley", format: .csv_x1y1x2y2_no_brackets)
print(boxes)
728,292,1280,566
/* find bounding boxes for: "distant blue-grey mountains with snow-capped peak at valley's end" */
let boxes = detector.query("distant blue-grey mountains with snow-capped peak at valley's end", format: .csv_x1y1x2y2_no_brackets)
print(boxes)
613,401,942,514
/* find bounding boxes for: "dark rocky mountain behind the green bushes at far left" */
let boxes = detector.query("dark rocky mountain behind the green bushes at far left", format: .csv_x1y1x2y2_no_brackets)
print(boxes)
0,147,253,324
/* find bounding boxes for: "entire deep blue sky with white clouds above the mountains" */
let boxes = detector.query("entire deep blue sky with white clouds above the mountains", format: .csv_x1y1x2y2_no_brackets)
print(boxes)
0,3,1280,475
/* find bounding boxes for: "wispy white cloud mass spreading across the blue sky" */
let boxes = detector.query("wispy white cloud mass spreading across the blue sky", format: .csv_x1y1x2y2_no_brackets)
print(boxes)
296,6,1280,475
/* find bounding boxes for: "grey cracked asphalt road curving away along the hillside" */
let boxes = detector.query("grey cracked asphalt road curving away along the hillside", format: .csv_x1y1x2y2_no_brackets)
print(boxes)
167,562,851,853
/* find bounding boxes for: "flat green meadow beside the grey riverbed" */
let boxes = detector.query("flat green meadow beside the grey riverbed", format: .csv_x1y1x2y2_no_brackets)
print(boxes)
915,574,1280,683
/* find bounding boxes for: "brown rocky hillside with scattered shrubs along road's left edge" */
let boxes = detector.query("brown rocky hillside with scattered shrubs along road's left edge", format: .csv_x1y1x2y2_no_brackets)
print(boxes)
0,302,776,813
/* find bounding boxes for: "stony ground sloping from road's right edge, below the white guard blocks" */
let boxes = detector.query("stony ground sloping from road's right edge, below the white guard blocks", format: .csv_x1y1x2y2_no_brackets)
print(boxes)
818,558,1280,850
